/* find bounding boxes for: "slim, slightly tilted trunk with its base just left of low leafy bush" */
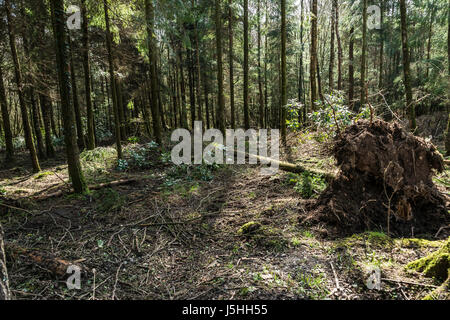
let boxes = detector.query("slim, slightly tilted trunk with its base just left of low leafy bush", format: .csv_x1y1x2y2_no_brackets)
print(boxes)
103,0,123,159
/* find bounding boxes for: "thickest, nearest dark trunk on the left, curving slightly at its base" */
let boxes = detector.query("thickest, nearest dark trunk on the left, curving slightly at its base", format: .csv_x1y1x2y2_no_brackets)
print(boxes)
50,0,89,193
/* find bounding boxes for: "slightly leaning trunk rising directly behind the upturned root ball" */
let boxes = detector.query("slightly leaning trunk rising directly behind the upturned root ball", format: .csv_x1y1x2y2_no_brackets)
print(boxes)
400,0,416,132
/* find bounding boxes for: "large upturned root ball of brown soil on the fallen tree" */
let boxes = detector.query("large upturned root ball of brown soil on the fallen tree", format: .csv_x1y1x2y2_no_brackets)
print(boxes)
301,120,450,236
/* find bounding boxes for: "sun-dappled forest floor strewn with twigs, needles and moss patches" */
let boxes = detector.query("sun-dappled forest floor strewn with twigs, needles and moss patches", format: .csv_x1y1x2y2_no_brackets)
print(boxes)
0,130,450,300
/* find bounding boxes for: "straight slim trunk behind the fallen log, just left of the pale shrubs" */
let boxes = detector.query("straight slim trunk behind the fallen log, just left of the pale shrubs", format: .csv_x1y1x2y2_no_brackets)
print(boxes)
280,0,287,145
